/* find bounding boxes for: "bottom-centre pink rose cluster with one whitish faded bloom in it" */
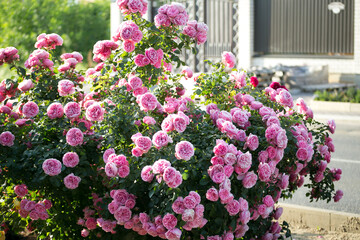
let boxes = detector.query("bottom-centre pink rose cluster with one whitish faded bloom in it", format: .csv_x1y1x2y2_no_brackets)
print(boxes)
172,191,208,231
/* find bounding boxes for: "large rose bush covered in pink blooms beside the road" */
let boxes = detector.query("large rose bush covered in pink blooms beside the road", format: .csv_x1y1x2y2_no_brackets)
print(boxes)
0,0,343,240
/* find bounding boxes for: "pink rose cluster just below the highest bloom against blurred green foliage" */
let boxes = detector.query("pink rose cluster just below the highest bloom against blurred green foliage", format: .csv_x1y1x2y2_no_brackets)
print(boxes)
25,49,54,71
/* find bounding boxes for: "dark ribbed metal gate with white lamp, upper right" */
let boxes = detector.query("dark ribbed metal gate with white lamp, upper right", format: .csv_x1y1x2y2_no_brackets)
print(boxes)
254,0,354,56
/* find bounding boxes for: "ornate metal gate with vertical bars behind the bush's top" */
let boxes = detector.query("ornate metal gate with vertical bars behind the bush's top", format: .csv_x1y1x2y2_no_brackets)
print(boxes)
150,0,238,72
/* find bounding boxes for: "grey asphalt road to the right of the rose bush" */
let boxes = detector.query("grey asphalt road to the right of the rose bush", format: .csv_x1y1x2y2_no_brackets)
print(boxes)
280,113,360,214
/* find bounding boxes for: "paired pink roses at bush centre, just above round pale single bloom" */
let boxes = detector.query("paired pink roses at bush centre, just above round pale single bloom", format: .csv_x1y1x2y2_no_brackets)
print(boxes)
161,111,190,133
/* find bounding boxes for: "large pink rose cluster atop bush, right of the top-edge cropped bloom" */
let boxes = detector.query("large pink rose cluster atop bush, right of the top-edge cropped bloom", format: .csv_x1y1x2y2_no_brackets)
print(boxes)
154,2,189,27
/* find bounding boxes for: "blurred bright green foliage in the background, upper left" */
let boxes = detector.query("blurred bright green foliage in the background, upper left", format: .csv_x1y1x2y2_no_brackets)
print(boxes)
0,0,110,61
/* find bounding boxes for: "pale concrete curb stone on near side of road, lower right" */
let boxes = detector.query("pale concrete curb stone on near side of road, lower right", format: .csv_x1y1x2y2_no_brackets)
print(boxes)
279,203,360,233
